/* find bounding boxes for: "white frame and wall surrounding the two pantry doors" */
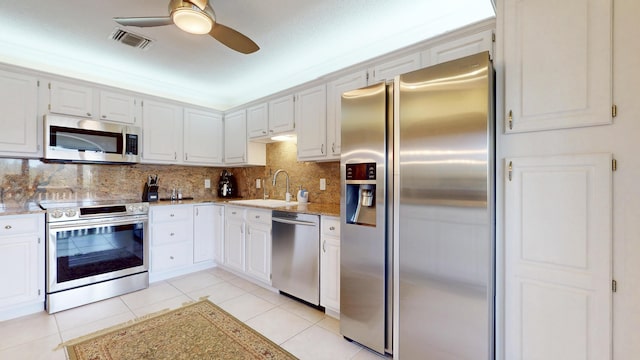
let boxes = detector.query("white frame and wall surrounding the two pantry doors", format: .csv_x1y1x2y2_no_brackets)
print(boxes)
496,0,640,360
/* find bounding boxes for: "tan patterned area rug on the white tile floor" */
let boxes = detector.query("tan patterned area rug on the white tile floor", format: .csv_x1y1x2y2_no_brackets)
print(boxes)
63,300,296,360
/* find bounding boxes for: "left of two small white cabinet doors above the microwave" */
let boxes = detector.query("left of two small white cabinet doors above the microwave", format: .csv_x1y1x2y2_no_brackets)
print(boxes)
49,81,93,117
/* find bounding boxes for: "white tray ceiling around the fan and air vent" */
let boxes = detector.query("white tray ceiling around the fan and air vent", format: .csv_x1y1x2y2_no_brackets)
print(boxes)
0,0,495,110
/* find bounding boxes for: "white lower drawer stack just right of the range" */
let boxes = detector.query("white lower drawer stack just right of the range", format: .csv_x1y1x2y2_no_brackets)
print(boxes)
149,205,194,280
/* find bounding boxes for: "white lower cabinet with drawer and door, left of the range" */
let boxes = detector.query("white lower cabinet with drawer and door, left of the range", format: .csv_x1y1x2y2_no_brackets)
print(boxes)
0,214,45,321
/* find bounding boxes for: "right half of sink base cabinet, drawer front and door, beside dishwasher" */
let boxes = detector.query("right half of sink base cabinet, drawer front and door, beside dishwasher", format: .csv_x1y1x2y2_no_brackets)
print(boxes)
245,209,271,284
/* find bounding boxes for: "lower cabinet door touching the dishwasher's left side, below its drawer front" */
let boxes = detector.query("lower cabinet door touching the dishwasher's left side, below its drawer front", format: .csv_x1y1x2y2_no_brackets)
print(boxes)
246,222,271,284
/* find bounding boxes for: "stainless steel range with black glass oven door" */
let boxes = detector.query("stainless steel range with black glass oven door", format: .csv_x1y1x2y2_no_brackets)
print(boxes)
40,200,149,314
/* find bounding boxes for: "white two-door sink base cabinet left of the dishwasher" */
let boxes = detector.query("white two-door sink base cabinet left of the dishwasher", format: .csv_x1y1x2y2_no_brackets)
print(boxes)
224,206,271,285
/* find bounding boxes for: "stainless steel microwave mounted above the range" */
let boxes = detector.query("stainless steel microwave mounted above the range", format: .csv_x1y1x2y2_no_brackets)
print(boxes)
44,115,142,163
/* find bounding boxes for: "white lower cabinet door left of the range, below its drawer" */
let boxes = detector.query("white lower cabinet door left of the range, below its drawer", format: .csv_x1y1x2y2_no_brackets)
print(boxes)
0,234,44,309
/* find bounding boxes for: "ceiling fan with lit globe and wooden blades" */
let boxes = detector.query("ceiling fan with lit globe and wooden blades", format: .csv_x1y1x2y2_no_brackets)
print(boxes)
113,0,260,54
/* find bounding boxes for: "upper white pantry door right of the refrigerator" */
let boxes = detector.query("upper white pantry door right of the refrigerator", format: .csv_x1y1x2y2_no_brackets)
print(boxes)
503,0,613,133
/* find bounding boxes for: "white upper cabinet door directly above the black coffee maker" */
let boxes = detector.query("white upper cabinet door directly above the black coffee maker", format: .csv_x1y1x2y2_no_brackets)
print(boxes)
224,110,247,164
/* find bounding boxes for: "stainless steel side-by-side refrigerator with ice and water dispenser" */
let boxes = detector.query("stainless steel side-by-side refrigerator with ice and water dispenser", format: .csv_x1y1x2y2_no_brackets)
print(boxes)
340,52,495,360
